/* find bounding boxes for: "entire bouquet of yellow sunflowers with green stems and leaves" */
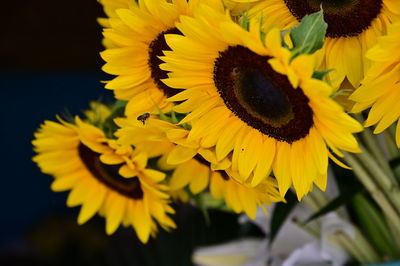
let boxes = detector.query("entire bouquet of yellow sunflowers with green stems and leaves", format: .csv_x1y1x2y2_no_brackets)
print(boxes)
32,0,400,265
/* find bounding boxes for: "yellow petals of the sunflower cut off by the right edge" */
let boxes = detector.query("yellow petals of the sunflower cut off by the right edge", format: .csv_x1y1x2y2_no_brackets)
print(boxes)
350,22,400,147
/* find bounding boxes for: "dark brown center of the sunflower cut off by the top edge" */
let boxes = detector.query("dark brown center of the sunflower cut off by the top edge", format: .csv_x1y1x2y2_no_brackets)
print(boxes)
284,0,382,38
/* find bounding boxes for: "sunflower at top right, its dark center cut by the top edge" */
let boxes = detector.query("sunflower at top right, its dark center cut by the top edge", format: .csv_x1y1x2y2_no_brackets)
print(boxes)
230,0,400,88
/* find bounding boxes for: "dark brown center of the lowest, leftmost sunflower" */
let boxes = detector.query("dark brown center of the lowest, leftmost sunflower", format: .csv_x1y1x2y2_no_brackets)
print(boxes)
78,143,143,199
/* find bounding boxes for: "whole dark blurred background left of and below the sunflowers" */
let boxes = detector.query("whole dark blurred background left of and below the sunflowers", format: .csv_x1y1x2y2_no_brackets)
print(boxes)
0,0,261,266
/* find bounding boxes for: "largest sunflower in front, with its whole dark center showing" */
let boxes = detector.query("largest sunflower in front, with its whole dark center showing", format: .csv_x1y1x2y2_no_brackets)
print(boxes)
161,6,362,199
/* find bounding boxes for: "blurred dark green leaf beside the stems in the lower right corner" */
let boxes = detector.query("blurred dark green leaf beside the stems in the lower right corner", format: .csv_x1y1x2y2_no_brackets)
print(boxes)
353,195,398,259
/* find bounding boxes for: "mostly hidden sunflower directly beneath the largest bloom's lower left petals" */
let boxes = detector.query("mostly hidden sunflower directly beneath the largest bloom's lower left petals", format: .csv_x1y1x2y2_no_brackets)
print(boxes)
116,116,282,219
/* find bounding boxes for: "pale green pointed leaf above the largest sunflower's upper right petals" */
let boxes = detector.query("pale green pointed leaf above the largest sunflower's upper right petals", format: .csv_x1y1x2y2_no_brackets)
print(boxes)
290,9,328,59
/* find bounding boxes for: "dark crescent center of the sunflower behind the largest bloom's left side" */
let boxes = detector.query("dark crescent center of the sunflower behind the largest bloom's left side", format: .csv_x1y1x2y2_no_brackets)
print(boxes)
148,28,182,97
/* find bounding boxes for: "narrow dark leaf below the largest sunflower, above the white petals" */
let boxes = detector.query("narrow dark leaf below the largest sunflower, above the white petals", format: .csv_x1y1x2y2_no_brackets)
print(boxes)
269,190,298,243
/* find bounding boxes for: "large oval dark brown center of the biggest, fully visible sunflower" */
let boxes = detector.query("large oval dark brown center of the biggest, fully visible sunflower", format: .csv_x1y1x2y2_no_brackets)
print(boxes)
214,46,313,143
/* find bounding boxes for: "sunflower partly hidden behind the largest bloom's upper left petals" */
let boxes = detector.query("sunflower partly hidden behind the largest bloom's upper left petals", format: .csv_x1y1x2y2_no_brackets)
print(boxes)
101,0,223,116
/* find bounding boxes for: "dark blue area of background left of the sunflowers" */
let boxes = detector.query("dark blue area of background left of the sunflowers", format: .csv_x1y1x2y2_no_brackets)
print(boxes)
0,71,111,245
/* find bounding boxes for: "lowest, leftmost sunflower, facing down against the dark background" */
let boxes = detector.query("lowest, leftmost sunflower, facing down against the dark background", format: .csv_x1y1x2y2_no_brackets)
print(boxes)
32,117,175,243
